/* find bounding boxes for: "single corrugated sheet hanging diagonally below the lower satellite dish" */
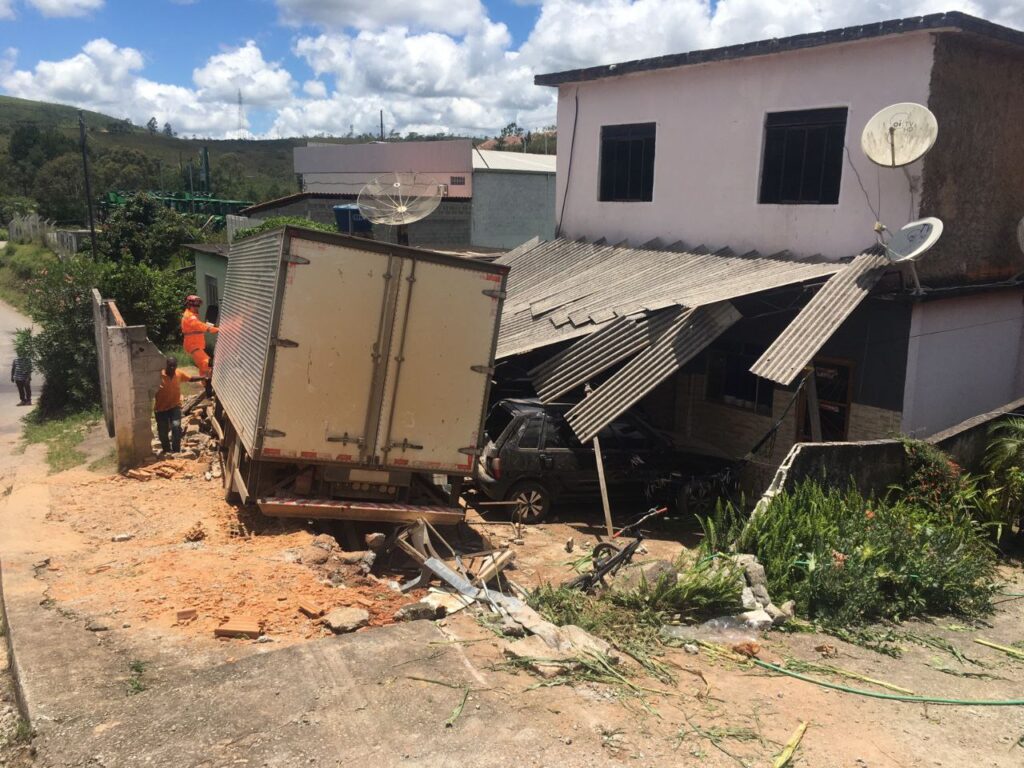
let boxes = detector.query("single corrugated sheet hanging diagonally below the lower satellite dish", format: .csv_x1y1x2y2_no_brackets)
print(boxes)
751,250,892,386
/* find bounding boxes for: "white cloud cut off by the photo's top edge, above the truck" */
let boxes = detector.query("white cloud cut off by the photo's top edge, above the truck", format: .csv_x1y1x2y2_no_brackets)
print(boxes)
276,0,485,33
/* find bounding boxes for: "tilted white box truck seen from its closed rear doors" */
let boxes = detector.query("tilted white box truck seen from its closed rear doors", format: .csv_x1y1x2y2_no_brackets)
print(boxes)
213,227,508,523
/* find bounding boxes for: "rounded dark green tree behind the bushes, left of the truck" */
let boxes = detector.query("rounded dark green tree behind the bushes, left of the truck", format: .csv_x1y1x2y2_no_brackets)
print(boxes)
97,195,197,268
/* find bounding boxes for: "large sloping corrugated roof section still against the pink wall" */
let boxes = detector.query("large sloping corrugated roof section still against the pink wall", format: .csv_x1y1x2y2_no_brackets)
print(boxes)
497,239,845,357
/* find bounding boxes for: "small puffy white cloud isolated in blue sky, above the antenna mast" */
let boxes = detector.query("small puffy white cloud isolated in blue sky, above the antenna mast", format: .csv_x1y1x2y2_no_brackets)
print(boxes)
193,40,295,106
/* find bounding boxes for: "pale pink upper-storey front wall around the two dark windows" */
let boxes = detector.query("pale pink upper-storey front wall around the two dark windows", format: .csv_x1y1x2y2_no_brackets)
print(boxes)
556,33,942,258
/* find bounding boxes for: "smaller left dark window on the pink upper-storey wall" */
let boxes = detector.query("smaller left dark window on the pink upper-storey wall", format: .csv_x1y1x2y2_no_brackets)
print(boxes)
598,123,654,203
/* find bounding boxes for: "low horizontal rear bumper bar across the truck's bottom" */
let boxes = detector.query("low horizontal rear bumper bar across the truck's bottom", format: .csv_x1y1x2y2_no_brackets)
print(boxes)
256,497,466,525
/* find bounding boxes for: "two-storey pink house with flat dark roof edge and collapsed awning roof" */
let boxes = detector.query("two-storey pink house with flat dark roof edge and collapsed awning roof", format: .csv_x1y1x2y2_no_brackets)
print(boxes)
499,13,1024,487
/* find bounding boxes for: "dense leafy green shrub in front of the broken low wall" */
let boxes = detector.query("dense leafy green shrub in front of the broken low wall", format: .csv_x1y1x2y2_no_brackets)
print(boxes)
737,481,995,626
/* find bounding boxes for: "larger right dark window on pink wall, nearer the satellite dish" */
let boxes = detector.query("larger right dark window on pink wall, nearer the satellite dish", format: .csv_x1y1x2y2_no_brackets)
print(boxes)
761,106,847,205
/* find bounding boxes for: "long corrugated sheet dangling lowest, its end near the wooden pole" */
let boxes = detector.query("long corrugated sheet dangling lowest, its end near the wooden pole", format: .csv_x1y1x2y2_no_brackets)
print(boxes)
565,301,740,442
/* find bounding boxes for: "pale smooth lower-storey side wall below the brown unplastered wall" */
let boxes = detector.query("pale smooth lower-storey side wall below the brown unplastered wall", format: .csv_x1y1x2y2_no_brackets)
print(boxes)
901,291,1024,437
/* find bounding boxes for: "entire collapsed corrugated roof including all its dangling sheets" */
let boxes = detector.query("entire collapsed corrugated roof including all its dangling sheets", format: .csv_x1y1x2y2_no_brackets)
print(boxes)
497,238,891,441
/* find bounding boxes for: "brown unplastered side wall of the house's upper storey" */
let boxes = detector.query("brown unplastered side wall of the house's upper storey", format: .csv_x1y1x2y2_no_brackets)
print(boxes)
919,33,1024,285
